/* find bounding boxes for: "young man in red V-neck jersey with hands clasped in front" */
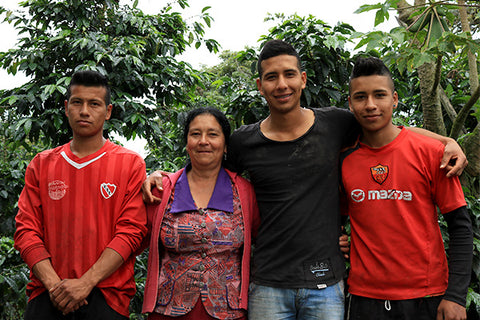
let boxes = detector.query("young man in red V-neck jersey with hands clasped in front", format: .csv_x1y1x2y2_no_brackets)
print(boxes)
14,71,146,320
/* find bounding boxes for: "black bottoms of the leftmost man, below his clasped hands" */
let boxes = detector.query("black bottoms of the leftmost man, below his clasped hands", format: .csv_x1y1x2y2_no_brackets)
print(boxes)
25,288,128,320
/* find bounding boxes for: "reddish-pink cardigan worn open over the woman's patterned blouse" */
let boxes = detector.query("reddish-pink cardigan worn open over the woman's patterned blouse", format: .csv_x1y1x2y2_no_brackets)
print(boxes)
142,169,260,313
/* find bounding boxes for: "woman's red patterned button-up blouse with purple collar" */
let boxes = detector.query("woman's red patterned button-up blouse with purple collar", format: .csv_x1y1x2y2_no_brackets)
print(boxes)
154,169,246,319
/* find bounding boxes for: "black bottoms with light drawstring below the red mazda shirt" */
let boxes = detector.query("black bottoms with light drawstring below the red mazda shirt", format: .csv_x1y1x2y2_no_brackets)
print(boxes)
345,295,443,320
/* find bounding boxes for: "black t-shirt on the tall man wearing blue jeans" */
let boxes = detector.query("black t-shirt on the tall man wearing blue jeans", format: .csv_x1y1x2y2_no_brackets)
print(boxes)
228,107,359,288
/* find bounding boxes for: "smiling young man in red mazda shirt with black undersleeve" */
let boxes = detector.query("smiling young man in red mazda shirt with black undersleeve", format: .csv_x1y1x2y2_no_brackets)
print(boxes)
342,58,473,320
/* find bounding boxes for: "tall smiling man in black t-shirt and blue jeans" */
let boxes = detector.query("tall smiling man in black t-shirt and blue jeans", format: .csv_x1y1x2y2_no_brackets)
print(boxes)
228,40,359,319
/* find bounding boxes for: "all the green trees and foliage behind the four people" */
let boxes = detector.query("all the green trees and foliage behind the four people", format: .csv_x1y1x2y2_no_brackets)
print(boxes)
0,0,480,319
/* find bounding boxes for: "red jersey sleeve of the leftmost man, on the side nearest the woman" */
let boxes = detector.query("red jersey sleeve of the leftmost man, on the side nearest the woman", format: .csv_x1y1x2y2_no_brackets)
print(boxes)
107,156,147,261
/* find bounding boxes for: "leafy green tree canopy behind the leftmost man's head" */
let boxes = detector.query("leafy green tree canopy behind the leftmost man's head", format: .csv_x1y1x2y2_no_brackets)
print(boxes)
0,0,218,151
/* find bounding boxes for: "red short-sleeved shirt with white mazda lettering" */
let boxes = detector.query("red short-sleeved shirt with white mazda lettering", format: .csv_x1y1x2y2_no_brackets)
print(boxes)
342,128,466,300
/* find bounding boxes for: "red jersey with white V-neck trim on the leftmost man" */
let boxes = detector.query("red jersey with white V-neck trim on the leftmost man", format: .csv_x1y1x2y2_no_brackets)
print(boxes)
15,141,146,316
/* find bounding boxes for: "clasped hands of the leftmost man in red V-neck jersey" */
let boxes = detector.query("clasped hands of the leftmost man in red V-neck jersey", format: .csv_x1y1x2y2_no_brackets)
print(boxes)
49,279,93,315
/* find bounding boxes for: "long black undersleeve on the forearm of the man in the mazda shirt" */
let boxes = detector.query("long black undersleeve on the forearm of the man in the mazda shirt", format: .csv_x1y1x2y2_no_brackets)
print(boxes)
443,207,473,306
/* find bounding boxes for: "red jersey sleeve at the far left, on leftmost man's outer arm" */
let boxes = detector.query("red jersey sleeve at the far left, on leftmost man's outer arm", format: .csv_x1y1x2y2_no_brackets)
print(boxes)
14,155,50,269
